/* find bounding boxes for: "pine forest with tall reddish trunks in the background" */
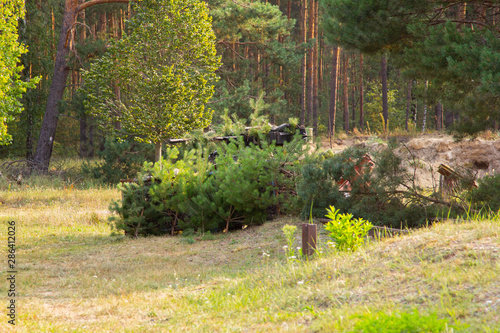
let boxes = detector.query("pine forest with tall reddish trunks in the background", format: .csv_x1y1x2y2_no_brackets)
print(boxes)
0,0,500,163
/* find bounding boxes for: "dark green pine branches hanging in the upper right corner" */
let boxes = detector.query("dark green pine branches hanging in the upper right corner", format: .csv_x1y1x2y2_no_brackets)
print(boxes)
322,0,500,134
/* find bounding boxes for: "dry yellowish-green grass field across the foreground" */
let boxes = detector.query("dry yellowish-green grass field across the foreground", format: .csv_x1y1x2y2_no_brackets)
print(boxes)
0,185,500,332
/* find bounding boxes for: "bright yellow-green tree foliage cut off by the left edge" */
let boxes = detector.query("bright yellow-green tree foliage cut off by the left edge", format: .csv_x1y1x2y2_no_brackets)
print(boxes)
0,0,39,145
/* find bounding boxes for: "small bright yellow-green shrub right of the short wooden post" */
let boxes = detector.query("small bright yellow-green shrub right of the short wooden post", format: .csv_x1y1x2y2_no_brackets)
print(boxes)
325,206,372,252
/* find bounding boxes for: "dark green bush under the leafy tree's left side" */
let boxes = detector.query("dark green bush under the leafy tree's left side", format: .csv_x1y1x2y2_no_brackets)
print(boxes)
82,137,154,184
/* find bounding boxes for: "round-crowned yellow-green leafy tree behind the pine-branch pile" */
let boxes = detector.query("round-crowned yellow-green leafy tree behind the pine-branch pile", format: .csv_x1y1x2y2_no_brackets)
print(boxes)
84,0,220,161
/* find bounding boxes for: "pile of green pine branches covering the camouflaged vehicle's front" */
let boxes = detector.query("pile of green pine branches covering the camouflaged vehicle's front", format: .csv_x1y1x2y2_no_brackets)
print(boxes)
113,136,303,234
